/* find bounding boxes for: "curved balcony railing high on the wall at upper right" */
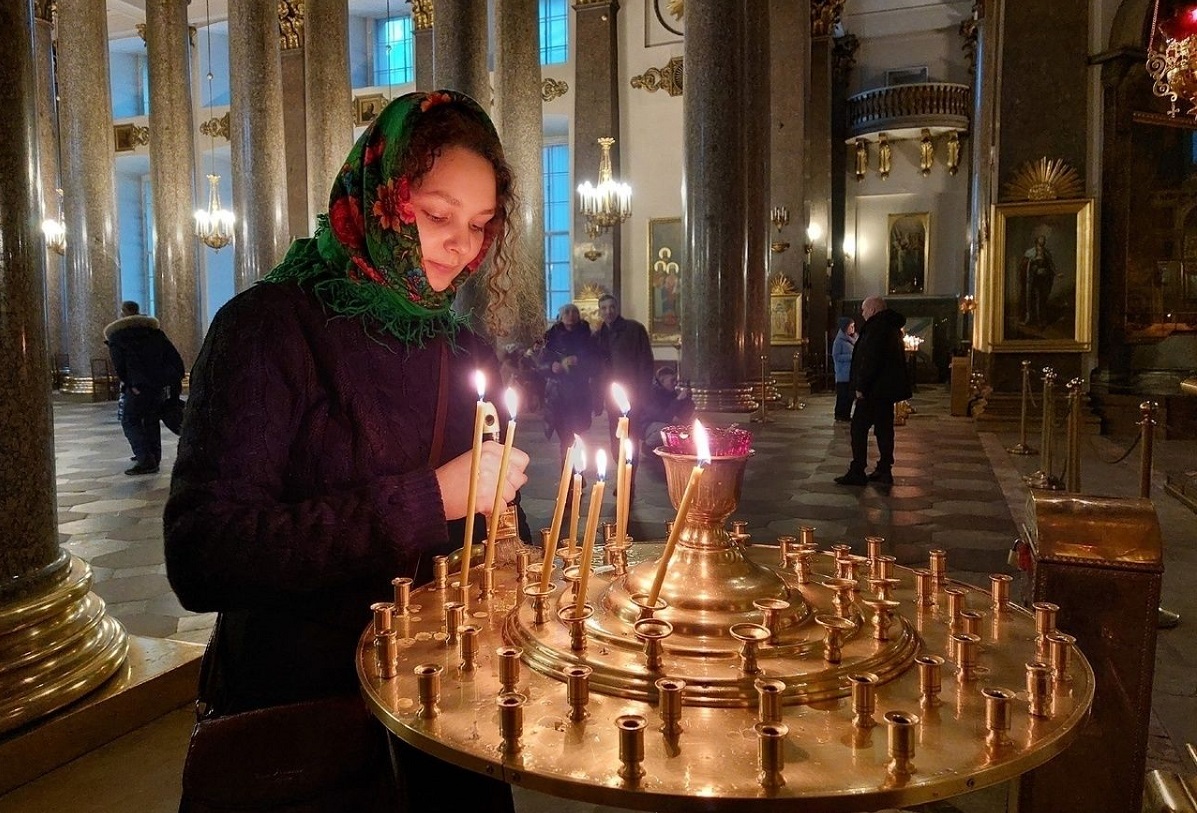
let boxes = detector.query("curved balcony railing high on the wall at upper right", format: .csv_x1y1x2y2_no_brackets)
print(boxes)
847,81,972,138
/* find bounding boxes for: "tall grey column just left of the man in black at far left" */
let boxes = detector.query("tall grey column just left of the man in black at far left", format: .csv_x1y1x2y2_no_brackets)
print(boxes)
57,0,121,393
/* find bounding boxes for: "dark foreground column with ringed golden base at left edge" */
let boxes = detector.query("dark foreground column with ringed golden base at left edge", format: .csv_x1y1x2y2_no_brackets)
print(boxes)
0,0,128,734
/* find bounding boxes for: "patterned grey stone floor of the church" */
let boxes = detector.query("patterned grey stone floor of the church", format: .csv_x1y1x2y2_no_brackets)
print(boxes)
0,386,1197,813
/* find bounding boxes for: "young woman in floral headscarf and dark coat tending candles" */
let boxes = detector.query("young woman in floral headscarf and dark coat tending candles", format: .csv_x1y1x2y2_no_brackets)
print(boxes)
164,91,528,811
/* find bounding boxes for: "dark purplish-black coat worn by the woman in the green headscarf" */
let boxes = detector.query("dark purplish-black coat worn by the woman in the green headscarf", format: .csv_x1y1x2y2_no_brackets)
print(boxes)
164,284,499,712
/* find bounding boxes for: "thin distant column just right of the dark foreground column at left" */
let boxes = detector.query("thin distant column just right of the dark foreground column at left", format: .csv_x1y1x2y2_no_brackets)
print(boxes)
34,0,66,357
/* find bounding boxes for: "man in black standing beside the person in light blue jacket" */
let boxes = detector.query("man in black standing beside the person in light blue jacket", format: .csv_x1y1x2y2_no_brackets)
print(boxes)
836,297,911,486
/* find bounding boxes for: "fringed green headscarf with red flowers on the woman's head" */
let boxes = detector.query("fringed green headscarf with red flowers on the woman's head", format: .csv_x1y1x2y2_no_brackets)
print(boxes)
261,91,502,346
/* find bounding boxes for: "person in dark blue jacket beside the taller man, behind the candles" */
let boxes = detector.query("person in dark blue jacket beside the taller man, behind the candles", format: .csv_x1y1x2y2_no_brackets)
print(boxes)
539,302,595,460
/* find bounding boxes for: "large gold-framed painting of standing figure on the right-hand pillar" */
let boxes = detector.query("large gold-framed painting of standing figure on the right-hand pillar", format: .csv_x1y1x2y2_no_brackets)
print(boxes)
983,200,1093,351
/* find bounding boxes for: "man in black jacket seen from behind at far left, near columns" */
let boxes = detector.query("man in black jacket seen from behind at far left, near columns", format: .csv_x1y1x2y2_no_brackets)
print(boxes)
104,302,184,474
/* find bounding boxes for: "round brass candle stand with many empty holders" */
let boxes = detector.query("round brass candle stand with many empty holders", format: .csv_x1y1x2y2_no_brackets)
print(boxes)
357,428,1094,813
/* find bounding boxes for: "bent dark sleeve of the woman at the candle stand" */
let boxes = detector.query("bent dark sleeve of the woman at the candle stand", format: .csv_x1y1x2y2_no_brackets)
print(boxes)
164,286,448,612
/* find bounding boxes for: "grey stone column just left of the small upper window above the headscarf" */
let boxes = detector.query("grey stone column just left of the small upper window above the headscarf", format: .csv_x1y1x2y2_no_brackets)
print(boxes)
304,0,353,231
